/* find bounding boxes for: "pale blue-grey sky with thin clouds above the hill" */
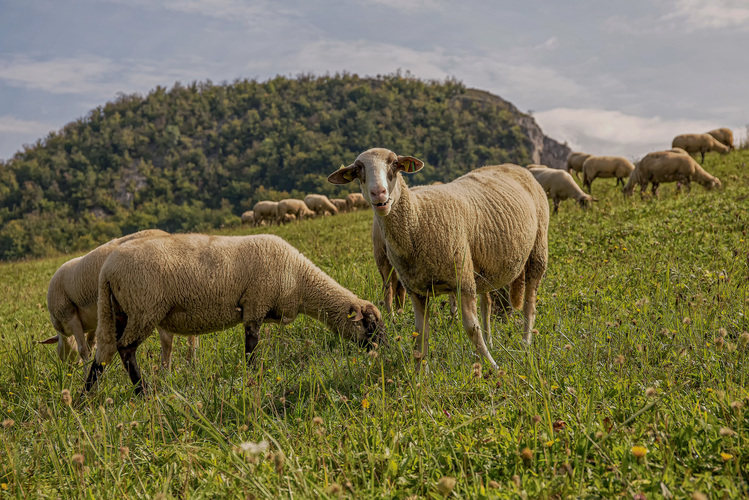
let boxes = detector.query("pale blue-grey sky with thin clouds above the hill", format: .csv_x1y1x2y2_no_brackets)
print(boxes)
0,0,749,159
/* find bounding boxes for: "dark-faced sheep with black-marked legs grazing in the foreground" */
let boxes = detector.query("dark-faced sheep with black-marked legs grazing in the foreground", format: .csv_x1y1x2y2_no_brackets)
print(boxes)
85,234,385,394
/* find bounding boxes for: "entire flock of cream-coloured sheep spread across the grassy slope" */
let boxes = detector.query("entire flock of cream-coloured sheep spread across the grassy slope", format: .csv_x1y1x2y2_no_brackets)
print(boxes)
43,129,733,393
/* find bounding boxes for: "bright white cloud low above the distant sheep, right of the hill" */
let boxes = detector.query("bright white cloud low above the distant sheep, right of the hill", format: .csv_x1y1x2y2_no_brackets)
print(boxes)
534,108,741,158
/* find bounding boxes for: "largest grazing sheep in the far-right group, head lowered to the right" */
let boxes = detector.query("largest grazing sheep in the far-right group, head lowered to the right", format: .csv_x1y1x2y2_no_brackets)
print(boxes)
622,147,722,196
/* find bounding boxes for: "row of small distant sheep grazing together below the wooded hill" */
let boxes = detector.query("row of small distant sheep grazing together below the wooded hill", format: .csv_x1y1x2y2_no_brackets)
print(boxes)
241,193,369,226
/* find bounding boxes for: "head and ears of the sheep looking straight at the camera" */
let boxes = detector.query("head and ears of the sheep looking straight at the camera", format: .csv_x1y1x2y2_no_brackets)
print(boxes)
328,148,424,216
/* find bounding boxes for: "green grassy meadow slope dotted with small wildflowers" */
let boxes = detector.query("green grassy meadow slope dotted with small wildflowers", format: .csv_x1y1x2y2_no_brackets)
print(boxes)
0,150,749,498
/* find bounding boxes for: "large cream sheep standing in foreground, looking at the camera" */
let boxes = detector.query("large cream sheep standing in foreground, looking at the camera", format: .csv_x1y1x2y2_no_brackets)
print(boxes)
328,148,549,368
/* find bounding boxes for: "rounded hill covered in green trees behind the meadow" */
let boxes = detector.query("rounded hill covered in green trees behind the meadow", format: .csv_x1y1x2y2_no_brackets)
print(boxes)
0,75,569,260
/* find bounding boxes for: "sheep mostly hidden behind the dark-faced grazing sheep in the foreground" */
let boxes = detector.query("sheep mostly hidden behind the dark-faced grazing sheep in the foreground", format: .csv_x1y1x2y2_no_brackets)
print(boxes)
40,229,197,369
